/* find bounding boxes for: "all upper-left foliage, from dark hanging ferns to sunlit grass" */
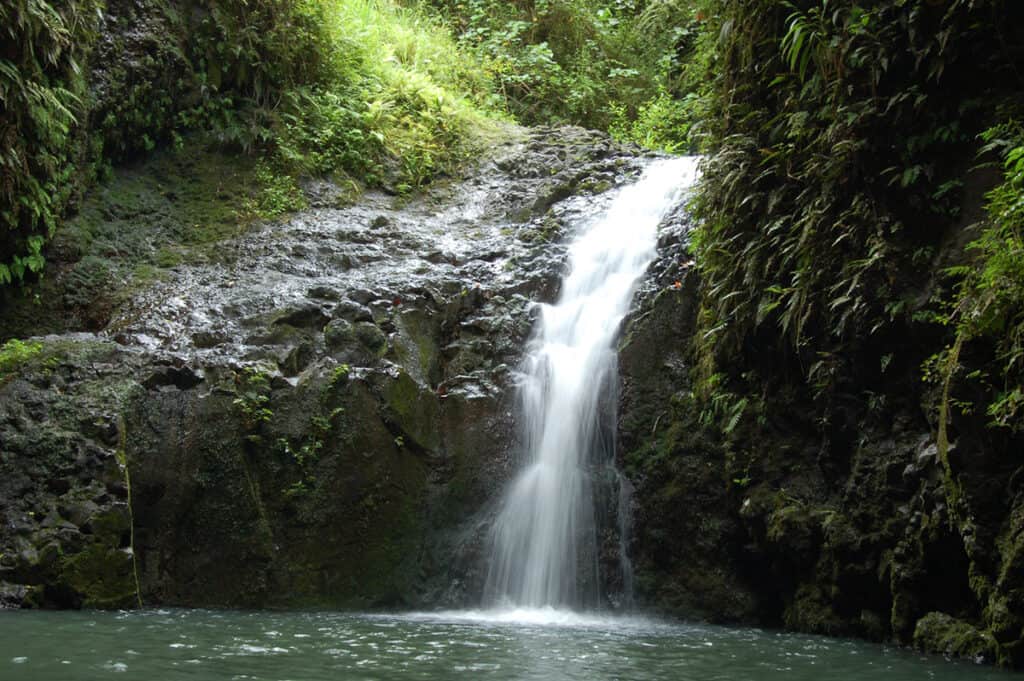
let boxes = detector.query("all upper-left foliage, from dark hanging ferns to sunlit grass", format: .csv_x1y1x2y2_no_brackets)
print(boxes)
0,0,501,286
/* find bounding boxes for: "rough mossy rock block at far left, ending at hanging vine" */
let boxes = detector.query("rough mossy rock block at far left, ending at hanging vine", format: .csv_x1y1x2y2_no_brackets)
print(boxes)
0,338,142,607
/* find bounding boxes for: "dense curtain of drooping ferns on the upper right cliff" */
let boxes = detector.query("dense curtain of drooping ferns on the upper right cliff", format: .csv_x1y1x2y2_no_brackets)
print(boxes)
696,0,1016,409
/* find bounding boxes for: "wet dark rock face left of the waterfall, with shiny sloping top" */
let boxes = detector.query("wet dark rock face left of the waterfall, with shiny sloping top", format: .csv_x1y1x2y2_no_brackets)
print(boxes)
0,124,642,607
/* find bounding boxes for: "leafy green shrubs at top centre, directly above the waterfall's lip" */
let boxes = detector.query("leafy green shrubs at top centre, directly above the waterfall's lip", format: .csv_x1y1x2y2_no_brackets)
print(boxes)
425,0,697,150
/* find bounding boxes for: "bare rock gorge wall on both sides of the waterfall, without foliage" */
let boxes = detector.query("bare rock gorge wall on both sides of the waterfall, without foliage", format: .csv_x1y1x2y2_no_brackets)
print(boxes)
0,124,1021,663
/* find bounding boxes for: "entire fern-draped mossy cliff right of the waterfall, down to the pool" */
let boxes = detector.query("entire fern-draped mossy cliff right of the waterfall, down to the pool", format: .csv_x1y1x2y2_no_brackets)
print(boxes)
622,0,1024,665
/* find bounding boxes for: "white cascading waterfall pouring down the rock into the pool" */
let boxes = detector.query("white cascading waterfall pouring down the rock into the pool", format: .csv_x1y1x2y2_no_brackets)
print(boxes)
485,158,696,608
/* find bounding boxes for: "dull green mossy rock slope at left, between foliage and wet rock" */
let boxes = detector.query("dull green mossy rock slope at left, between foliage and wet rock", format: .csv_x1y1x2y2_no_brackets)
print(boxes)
0,146,257,339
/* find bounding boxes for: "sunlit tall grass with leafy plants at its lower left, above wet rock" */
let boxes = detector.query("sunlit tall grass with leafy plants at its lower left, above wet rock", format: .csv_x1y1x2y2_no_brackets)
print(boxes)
268,0,503,191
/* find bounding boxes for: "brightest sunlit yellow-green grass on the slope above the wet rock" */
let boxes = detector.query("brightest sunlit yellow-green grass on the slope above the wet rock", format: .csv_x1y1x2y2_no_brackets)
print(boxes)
305,0,509,188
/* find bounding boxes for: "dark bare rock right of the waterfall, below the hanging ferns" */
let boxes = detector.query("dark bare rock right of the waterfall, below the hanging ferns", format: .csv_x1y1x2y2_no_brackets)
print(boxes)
620,191,1024,666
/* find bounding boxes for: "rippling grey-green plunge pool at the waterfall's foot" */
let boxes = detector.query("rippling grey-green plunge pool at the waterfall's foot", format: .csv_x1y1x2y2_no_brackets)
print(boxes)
0,608,1011,681
